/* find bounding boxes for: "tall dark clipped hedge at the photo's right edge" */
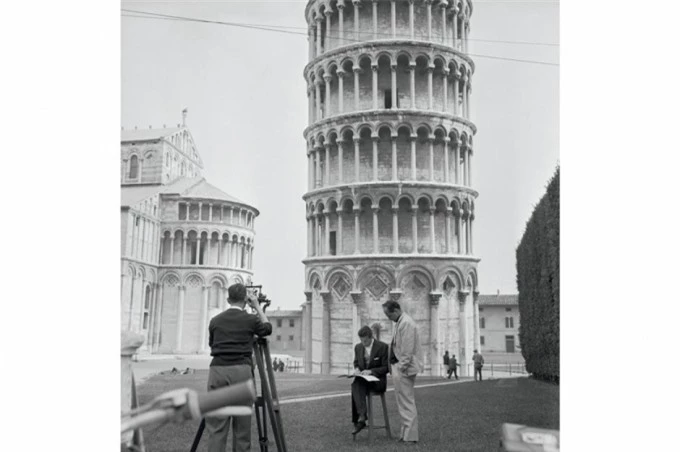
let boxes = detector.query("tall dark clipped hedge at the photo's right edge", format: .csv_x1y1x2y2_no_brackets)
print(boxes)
516,167,560,382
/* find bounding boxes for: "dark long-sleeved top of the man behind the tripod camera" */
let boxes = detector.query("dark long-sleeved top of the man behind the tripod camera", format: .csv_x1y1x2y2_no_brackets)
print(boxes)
208,307,272,366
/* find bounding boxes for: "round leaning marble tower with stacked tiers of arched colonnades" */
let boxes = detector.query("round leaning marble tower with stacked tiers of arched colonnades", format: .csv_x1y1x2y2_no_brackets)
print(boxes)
303,0,479,375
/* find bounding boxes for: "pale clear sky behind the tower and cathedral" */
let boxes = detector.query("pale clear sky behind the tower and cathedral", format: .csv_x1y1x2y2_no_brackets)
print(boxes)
121,0,560,309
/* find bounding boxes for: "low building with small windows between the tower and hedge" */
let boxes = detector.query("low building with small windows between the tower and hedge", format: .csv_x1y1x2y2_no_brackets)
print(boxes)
479,293,519,353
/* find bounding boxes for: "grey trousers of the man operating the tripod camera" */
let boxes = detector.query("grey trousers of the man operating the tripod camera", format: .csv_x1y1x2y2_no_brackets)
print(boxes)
205,364,252,452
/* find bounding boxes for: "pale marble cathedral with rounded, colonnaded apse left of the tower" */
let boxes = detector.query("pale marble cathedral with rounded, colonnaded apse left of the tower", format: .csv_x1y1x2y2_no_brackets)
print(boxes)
120,125,259,354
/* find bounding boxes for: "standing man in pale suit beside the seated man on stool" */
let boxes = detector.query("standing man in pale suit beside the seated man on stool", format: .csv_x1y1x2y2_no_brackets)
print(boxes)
382,301,422,443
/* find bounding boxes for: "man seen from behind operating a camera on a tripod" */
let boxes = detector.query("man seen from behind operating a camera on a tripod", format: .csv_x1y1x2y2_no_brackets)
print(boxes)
205,284,272,452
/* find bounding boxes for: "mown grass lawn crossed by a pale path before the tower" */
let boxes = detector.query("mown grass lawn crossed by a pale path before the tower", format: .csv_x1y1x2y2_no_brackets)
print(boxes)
138,371,559,452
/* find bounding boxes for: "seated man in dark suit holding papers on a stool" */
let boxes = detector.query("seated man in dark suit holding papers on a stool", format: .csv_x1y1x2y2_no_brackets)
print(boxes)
352,326,388,434
